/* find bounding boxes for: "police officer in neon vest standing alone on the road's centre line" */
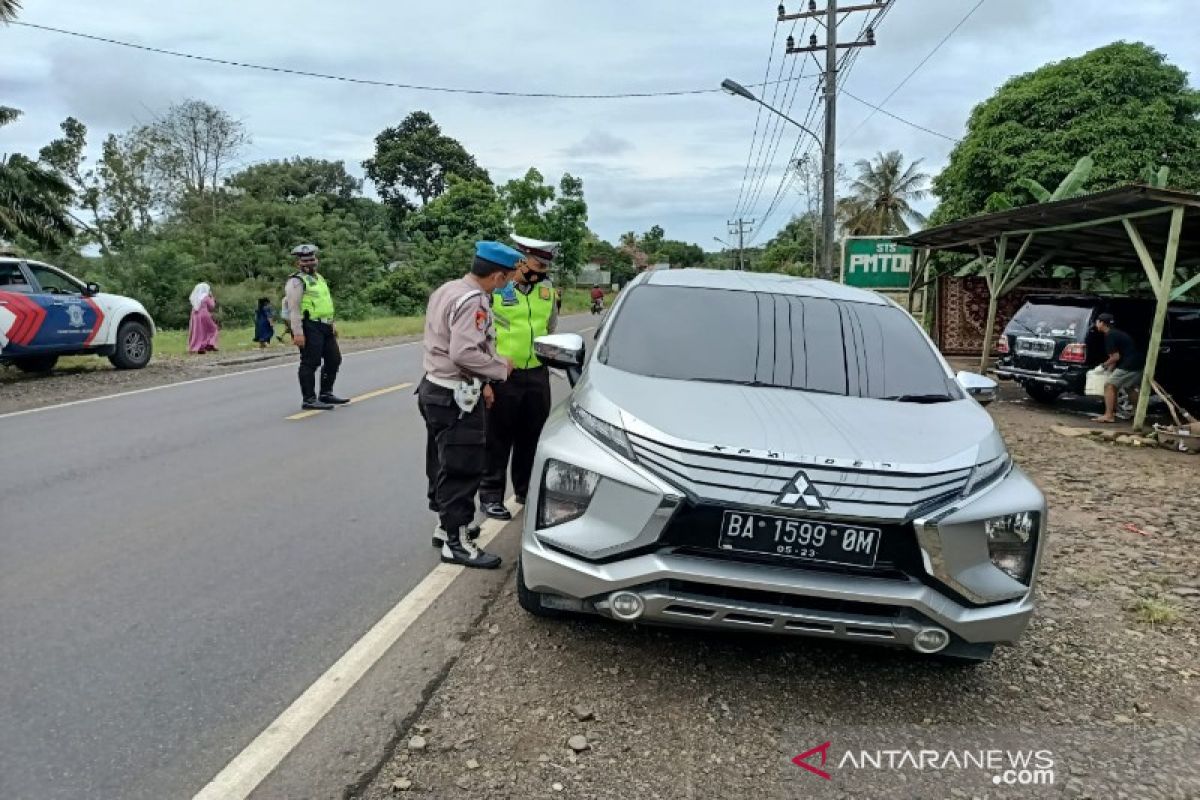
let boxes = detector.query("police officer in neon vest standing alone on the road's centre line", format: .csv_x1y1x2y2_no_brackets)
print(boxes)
283,245,350,411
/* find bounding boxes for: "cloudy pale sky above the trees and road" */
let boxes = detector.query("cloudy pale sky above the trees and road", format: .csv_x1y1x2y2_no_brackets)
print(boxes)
0,0,1200,249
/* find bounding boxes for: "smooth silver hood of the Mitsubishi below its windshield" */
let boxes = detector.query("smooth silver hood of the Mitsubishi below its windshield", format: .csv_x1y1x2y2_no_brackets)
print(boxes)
577,363,1004,471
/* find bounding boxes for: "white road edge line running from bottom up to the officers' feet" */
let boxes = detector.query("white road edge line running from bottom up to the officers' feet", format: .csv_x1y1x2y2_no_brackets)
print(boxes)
193,498,517,800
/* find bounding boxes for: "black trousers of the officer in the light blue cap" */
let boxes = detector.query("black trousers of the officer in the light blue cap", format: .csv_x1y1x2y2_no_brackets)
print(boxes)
416,380,487,530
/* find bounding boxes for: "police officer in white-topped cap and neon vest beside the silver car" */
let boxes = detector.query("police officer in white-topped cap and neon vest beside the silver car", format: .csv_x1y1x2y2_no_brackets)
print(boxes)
479,236,558,519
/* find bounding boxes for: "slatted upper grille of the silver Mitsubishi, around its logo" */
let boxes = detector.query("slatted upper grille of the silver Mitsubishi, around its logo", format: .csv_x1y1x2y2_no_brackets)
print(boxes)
629,432,971,522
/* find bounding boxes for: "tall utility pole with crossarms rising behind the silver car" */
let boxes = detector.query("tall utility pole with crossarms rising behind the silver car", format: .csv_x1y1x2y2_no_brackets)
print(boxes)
779,0,887,281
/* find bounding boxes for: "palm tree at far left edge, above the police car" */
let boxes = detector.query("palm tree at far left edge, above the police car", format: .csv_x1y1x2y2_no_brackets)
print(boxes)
0,107,74,246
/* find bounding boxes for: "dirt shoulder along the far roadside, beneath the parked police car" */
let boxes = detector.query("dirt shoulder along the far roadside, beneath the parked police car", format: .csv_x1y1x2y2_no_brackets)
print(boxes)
0,337,414,414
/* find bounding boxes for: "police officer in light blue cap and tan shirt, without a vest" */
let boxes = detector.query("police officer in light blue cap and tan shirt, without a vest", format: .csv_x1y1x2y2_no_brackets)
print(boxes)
416,241,522,569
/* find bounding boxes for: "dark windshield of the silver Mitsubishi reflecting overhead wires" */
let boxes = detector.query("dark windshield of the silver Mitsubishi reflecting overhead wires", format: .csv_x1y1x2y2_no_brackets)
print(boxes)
596,285,962,402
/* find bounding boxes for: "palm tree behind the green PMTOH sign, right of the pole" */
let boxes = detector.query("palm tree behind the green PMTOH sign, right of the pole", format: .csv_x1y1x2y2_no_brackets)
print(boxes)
838,150,929,236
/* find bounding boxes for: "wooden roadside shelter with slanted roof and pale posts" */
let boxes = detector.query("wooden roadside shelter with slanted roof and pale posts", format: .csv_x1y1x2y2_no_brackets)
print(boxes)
898,186,1200,429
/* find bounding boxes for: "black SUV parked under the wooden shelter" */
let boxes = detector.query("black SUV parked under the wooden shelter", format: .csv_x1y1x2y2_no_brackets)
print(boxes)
996,295,1200,407
